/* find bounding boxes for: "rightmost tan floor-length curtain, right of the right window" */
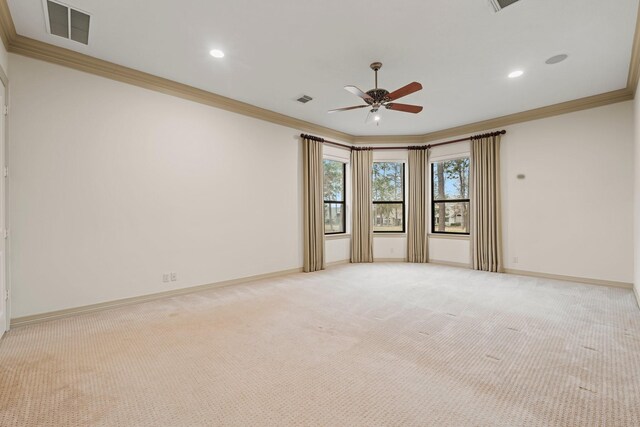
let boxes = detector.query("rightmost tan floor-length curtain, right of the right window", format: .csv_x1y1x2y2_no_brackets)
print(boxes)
471,135,503,272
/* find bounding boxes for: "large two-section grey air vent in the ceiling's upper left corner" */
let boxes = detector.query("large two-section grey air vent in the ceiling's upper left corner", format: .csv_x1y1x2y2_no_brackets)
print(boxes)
45,0,91,44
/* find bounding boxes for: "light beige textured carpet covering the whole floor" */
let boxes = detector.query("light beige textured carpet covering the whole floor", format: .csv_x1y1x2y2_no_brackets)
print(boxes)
0,264,640,426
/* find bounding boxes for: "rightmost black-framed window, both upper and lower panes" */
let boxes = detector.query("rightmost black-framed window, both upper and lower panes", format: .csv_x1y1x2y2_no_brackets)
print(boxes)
431,157,469,234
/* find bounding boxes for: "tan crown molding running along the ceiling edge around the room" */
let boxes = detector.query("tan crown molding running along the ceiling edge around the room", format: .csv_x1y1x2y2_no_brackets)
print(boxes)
0,0,640,144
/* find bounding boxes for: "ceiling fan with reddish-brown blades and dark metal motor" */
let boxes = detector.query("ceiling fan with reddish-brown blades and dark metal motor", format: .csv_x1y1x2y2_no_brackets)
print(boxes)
329,62,422,122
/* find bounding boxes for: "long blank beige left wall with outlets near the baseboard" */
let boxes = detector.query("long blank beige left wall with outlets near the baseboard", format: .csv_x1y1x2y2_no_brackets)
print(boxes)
9,54,324,318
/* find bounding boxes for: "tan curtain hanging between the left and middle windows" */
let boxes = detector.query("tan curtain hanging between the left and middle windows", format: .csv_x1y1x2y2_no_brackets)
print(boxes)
351,149,373,262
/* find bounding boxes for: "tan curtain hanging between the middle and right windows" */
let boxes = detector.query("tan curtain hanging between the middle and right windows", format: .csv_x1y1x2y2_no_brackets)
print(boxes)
407,148,429,262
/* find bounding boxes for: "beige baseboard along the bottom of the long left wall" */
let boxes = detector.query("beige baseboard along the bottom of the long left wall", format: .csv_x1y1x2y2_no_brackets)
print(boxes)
10,268,302,328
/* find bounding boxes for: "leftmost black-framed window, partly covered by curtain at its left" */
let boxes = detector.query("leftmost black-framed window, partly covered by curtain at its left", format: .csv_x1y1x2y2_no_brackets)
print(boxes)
323,160,346,234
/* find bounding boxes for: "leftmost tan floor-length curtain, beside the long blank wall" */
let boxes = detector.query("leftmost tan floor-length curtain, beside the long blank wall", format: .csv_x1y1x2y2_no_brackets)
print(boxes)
302,138,324,272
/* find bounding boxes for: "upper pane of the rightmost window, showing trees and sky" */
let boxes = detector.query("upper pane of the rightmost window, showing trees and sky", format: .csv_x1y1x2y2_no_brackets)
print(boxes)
431,157,469,200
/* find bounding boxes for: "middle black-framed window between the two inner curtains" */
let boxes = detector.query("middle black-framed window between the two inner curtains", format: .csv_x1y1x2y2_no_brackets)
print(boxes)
373,162,404,233
